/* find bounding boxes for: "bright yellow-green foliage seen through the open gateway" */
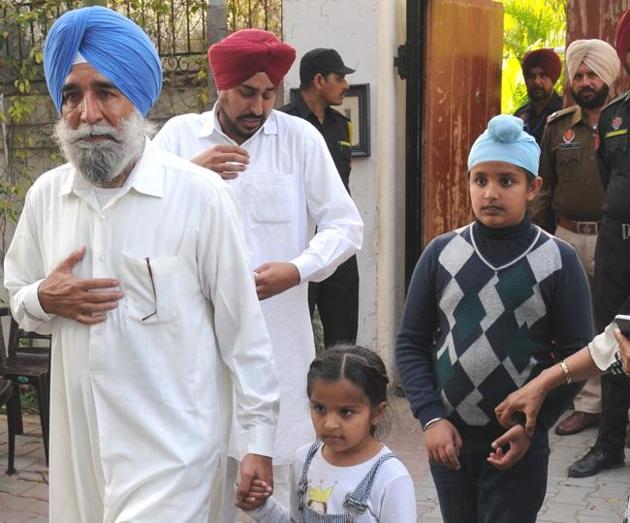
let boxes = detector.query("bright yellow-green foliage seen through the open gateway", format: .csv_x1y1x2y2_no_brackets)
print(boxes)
501,0,567,113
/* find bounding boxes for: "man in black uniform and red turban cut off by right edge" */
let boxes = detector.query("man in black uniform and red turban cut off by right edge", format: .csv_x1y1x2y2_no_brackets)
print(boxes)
569,9,630,477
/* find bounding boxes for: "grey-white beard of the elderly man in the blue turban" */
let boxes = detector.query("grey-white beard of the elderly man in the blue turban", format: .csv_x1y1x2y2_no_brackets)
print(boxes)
55,110,153,187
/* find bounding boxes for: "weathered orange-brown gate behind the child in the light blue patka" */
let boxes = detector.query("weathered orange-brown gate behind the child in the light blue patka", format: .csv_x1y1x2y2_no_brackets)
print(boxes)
422,0,503,245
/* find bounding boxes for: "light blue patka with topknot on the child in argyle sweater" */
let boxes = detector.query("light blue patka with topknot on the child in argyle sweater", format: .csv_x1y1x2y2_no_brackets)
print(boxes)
468,114,540,176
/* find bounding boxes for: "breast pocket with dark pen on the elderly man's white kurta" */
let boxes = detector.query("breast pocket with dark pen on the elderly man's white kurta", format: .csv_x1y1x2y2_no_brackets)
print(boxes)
120,253,177,325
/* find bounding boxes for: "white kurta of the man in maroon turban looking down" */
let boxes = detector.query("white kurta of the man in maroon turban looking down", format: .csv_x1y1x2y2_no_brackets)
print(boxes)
153,110,363,464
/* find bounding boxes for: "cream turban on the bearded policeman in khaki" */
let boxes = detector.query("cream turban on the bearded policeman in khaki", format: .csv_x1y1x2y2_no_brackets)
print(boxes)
566,39,621,87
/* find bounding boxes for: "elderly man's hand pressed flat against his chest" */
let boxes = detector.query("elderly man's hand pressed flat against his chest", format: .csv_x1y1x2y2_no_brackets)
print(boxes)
37,246,124,325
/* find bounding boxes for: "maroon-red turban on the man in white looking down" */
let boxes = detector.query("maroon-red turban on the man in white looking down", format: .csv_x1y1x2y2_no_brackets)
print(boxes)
208,29,295,91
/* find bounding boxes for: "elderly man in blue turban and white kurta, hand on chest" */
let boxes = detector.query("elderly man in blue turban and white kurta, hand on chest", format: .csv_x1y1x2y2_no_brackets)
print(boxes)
5,7,278,523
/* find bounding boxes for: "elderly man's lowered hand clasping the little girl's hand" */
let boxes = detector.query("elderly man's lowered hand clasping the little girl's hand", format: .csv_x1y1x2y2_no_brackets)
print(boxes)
235,454,273,510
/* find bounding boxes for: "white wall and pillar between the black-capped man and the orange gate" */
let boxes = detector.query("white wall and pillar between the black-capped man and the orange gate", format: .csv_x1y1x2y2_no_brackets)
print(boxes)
283,0,405,376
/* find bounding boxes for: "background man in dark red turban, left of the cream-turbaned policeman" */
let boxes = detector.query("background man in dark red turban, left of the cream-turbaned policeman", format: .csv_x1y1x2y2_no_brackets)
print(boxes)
514,49,562,145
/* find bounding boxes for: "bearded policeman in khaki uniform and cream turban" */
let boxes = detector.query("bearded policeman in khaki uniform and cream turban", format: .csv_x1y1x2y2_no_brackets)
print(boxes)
535,40,620,442
